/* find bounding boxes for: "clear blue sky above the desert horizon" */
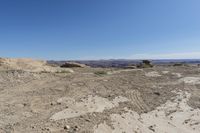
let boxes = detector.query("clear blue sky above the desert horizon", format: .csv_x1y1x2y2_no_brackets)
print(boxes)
0,0,200,60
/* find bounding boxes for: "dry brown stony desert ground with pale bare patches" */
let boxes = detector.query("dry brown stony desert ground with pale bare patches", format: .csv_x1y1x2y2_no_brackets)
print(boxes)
0,66,200,133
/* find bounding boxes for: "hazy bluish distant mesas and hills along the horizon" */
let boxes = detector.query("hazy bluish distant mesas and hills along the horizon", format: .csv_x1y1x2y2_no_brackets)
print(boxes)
48,59,200,68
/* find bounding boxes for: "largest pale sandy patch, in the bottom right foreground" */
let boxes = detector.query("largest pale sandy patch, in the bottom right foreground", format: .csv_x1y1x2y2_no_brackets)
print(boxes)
94,91,200,133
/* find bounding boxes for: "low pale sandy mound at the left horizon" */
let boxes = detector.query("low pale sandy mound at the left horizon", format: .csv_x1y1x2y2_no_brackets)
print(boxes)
0,58,73,72
